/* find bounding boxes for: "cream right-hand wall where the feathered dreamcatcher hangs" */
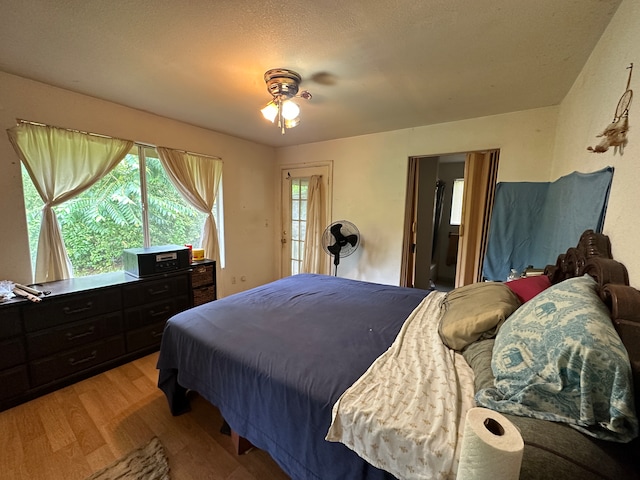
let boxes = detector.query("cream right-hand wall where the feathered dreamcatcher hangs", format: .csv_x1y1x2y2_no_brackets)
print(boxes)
551,0,640,288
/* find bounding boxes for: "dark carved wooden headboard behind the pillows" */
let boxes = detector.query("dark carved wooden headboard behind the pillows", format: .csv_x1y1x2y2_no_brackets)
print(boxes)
544,230,640,414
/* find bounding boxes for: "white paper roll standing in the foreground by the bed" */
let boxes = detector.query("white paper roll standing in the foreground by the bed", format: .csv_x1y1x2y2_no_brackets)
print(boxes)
456,407,524,480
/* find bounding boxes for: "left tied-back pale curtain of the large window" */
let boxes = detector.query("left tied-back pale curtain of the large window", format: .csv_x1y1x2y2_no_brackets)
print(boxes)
7,123,133,282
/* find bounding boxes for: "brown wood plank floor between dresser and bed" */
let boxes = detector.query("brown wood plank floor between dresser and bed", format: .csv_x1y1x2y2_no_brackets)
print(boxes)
0,354,289,480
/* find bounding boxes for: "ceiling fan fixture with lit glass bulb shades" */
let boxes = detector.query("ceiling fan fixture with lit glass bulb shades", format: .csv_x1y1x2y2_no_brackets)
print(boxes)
261,68,311,135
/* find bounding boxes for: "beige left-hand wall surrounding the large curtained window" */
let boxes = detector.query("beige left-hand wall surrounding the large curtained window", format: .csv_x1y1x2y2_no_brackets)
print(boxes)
0,72,277,295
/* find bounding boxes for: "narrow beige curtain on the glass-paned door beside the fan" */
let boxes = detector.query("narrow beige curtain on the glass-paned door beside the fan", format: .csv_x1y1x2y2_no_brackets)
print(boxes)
301,175,328,274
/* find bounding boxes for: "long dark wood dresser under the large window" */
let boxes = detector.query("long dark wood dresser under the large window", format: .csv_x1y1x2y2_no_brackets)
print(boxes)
0,262,215,411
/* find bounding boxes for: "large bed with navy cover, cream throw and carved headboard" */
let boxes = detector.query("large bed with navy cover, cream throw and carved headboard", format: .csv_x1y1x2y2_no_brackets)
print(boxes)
158,232,640,480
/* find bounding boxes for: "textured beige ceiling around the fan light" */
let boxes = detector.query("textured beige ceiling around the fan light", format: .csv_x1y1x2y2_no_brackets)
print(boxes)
0,0,620,146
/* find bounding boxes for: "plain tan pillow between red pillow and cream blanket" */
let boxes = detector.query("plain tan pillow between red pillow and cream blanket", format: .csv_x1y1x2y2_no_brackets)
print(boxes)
438,282,520,351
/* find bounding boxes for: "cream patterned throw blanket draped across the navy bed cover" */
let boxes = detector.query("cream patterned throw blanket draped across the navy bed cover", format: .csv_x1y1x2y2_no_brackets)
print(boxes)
326,292,474,479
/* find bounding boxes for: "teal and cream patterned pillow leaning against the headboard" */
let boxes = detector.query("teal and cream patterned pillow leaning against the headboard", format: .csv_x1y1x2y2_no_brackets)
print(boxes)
476,275,638,442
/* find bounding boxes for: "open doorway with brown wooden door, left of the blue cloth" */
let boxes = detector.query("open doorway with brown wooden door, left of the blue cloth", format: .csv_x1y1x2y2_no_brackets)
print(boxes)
400,150,499,291
